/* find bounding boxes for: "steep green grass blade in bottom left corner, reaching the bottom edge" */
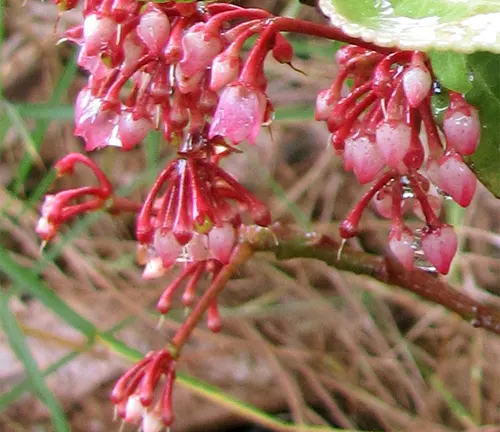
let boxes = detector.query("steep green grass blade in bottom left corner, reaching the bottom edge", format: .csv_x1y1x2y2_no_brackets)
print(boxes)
0,291,70,432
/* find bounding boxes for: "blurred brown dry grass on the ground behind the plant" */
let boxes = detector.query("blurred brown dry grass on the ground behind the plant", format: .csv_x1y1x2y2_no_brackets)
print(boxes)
0,0,500,432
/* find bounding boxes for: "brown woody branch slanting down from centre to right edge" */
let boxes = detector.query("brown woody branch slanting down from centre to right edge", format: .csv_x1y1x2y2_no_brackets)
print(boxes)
242,225,500,334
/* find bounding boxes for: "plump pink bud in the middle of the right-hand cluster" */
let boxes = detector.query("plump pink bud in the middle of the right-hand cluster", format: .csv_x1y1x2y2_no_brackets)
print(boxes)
376,120,411,168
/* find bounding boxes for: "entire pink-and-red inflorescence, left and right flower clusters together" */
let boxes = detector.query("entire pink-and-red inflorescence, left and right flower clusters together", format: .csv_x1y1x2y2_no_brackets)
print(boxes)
36,0,480,432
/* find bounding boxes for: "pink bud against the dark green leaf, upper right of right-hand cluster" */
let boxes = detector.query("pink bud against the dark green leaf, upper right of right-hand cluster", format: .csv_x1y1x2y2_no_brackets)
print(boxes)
443,103,481,155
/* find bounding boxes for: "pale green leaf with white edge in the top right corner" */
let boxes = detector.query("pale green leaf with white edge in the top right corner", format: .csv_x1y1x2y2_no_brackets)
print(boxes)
319,0,500,53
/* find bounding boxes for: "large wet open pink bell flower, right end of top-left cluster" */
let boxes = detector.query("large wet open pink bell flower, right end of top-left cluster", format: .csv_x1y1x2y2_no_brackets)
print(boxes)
209,83,267,144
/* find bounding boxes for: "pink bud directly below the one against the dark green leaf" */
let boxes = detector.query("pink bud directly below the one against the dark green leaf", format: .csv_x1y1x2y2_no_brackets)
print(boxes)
438,153,477,207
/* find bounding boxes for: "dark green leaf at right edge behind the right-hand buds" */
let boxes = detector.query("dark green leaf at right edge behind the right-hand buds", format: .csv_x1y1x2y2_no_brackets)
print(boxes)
465,52,500,198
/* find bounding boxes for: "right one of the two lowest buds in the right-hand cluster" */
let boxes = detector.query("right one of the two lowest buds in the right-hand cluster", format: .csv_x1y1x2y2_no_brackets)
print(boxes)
422,226,458,274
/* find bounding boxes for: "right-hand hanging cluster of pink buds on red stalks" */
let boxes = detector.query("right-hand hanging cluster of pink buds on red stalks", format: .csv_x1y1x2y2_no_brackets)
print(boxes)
316,45,480,274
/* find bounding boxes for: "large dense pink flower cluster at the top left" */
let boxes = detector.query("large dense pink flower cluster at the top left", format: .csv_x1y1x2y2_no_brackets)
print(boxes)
58,0,282,150
